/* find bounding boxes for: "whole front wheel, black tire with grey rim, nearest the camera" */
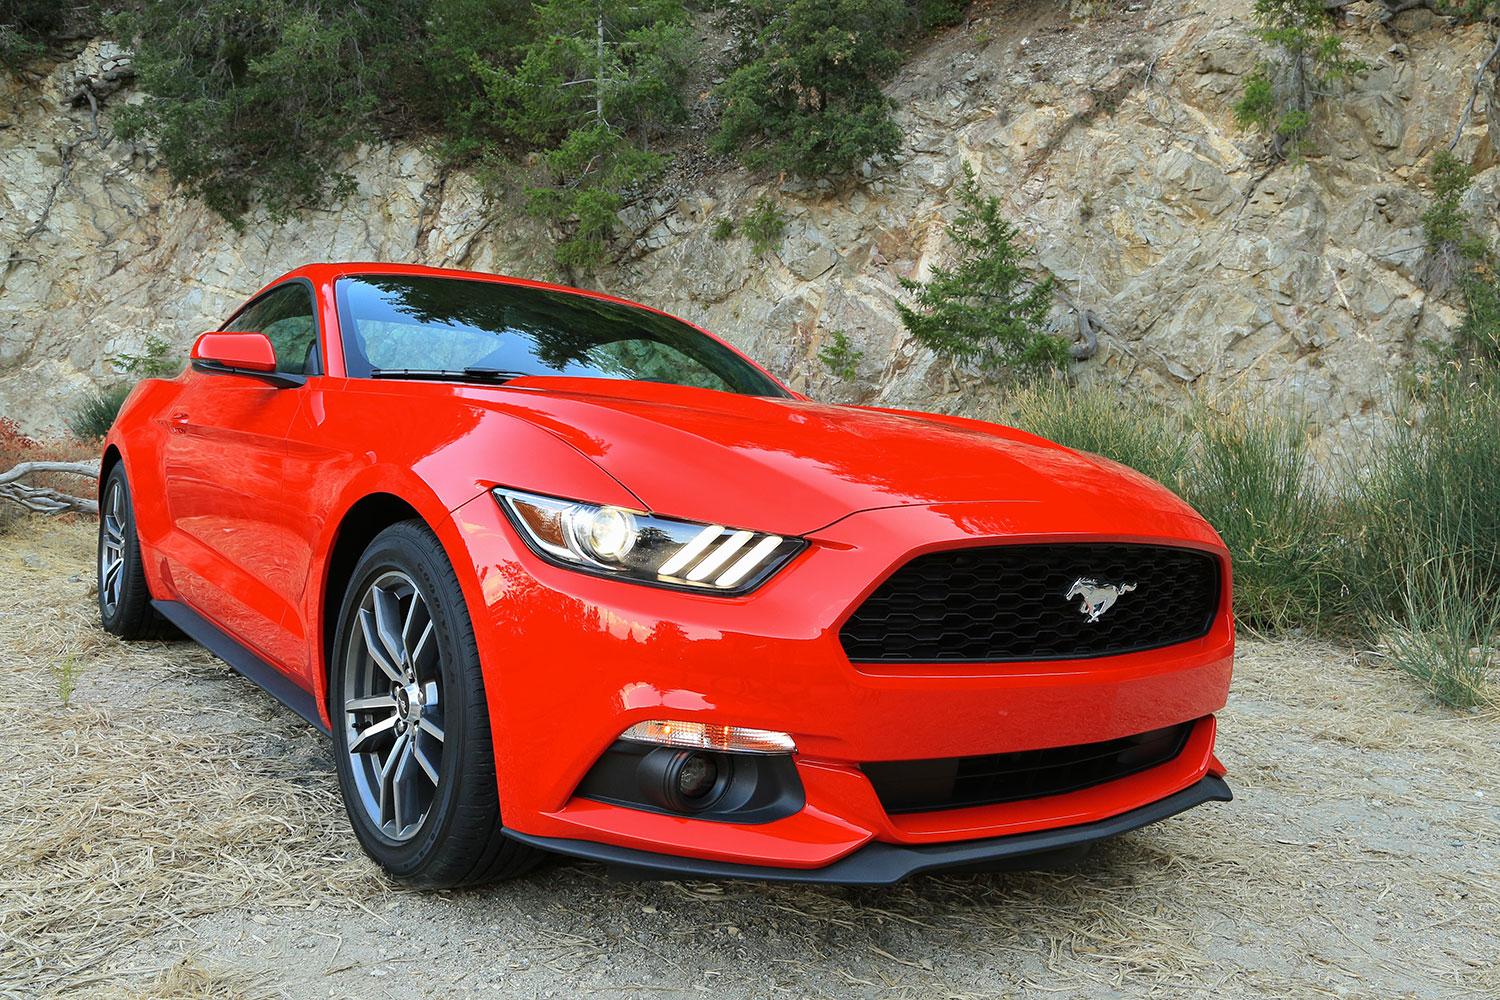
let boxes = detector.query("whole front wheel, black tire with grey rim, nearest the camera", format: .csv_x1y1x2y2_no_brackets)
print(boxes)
329,520,542,889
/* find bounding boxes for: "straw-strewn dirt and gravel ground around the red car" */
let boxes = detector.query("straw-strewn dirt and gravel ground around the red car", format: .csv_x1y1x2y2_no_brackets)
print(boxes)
0,522,1500,999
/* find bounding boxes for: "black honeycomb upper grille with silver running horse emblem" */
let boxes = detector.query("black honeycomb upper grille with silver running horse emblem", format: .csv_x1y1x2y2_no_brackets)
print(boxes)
839,543,1220,663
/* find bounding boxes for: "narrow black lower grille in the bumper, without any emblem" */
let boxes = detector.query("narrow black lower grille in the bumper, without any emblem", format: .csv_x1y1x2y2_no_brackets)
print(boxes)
864,723,1194,813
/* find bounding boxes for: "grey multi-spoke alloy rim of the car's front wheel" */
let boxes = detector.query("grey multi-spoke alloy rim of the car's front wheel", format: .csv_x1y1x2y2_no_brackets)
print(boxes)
344,570,444,843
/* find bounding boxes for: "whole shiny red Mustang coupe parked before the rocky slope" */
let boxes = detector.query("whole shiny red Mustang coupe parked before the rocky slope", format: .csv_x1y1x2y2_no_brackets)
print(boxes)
99,264,1235,886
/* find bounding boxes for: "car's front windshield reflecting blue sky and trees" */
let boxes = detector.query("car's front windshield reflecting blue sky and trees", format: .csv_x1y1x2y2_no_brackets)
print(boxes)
338,274,786,396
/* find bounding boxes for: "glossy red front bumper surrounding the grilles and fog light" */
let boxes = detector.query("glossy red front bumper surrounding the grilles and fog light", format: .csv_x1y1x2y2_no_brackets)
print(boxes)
455,493,1235,877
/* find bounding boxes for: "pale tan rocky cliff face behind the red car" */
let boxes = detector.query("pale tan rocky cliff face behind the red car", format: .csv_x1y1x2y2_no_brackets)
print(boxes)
0,1,1500,447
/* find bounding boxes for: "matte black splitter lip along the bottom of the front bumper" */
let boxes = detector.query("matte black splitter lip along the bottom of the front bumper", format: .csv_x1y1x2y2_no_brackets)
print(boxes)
506,775,1235,886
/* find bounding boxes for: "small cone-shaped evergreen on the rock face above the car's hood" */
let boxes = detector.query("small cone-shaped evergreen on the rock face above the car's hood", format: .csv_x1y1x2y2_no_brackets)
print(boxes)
897,163,1070,375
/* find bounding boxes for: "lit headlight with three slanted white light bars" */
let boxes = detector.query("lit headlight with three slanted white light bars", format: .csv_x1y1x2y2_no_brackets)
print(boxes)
495,487,803,594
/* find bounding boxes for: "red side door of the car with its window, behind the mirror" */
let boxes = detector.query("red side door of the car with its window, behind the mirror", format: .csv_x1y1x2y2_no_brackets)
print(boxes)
165,280,321,676
